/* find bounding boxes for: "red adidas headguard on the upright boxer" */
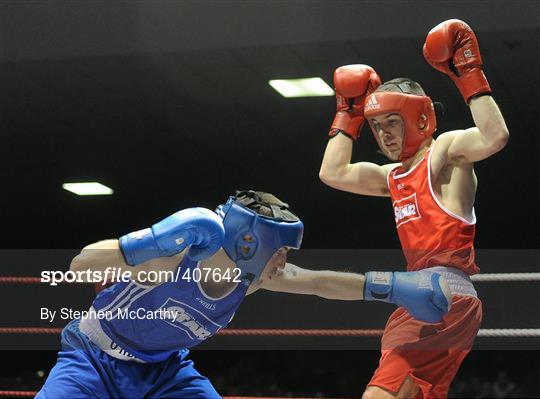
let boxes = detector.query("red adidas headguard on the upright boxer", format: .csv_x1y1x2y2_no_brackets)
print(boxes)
364,91,437,161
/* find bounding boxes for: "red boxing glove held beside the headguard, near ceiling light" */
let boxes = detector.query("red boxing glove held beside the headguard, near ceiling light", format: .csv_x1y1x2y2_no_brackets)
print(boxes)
328,64,381,140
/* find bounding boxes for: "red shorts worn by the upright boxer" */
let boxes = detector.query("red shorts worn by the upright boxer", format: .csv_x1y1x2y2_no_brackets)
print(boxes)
368,295,482,399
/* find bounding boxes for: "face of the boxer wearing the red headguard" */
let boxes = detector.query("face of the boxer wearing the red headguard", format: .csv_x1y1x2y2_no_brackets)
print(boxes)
369,113,404,161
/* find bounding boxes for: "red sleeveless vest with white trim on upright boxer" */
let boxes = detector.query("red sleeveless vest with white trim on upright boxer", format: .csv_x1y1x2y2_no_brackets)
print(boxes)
388,149,480,275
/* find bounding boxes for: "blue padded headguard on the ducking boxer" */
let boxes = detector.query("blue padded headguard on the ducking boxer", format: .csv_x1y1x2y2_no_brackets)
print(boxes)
216,191,304,283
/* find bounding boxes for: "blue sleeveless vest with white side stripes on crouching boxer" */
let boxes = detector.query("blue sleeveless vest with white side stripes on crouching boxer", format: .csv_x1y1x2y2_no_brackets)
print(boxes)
79,257,249,362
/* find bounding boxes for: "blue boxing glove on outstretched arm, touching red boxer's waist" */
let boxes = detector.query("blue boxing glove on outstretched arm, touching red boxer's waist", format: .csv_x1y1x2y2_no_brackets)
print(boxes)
364,271,452,323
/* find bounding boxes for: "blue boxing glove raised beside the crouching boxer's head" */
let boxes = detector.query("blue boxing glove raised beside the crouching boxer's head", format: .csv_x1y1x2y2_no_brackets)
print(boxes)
119,208,225,266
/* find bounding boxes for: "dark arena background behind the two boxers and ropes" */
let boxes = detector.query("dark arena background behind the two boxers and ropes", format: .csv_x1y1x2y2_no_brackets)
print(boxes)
0,0,540,398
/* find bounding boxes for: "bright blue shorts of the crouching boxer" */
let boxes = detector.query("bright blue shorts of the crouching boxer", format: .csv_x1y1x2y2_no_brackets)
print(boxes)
36,320,220,399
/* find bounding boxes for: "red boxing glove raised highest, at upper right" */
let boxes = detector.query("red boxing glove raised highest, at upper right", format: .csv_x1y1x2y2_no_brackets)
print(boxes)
423,19,491,103
